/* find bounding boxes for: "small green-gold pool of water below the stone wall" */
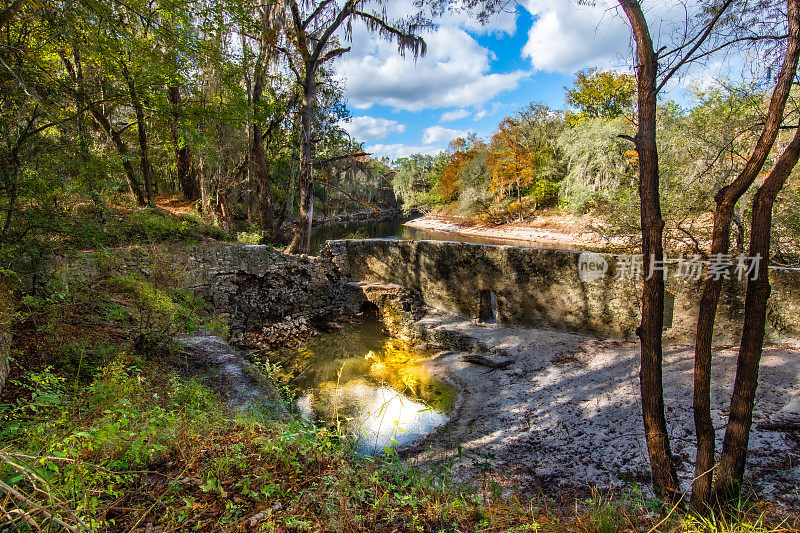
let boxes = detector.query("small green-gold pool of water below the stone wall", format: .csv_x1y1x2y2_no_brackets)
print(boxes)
255,319,456,453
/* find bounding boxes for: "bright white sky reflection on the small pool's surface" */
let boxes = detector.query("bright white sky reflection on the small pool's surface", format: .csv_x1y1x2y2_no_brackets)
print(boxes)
297,380,447,454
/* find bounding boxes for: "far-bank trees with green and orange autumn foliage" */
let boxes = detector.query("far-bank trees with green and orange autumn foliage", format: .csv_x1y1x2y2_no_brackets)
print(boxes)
394,70,800,261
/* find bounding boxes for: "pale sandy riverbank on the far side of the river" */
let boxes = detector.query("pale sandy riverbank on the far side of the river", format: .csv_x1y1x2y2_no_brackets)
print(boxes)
405,213,609,251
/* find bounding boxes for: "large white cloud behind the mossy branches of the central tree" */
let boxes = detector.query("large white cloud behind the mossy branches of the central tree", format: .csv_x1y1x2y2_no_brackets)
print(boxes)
335,0,530,111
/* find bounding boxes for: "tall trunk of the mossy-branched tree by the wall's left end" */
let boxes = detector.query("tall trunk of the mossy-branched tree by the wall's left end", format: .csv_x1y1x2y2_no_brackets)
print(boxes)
286,74,317,254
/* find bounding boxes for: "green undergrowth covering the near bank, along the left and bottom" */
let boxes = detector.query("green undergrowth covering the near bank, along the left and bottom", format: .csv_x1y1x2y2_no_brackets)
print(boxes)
0,251,791,533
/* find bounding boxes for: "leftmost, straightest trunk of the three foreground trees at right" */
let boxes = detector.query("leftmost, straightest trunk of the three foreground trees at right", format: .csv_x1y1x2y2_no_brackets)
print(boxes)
619,0,680,502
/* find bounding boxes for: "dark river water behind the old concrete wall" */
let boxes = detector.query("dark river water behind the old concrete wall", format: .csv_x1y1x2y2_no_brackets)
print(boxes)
311,217,544,254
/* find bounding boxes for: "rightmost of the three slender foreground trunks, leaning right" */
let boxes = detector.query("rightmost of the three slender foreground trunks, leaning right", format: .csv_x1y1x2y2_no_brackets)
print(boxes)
715,123,800,501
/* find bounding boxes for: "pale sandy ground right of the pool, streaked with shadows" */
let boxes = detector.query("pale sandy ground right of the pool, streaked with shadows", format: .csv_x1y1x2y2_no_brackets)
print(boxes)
403,314,800,507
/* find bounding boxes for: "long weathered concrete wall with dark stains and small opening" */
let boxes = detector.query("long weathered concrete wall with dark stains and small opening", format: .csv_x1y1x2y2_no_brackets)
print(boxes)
321,239,800,340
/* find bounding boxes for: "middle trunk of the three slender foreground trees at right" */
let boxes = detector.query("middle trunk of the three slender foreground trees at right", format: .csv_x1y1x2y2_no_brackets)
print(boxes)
692,0,800,512
